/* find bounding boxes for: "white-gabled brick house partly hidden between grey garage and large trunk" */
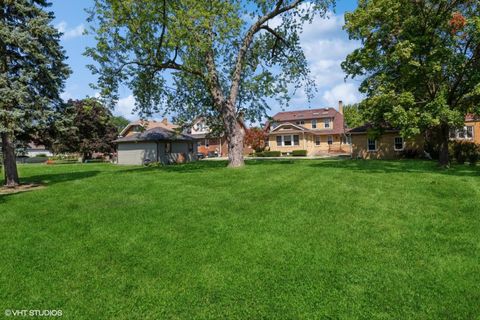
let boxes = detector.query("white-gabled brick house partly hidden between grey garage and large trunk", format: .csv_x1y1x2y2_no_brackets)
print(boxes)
186,117,228,157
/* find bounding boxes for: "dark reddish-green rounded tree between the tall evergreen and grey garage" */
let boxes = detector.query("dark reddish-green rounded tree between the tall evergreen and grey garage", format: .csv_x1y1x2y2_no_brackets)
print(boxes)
54,98,118,160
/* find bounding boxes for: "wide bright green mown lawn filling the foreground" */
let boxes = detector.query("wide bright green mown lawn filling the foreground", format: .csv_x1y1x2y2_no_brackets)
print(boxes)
0,160,480,319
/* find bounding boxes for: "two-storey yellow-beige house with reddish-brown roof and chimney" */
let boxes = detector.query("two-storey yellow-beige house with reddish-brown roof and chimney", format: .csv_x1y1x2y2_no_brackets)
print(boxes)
268,101,351,156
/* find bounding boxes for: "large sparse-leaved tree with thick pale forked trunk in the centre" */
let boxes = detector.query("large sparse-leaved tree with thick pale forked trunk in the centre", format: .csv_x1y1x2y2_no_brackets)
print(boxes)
87,0,333,167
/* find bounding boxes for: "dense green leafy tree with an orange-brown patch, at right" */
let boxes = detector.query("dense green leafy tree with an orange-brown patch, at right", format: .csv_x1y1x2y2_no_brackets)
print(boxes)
342,0,480,164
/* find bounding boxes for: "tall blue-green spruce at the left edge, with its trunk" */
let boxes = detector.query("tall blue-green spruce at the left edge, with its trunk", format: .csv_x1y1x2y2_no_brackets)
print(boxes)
0,0,69,187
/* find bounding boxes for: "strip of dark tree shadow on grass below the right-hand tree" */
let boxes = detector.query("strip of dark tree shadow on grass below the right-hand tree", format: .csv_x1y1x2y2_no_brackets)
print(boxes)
311,160,480,176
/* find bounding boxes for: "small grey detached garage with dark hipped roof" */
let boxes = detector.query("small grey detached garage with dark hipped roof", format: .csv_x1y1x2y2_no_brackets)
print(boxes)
115,128,197,165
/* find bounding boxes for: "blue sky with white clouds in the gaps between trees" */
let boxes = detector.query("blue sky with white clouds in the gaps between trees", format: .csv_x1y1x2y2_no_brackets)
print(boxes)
50,0,361,120
